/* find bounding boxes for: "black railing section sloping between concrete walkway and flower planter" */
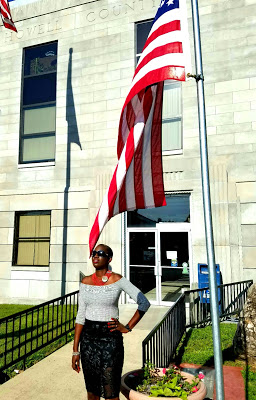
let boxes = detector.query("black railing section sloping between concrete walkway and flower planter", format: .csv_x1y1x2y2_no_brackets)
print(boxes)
142,294,186,368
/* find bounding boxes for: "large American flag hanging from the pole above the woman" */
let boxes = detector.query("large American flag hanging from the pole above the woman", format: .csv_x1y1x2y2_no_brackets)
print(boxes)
89,0,190,254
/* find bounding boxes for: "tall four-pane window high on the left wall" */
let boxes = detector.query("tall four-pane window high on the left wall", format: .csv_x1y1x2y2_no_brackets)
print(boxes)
19,42,57,163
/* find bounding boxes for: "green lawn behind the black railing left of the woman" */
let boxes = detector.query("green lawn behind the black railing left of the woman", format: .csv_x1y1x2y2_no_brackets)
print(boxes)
0,304,77,369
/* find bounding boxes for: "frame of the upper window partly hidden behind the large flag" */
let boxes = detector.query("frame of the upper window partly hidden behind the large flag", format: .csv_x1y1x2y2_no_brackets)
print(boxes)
134,18,183,156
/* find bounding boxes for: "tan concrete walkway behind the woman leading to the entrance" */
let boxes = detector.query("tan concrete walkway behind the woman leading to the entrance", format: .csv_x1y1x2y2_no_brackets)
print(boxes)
0,304,168,400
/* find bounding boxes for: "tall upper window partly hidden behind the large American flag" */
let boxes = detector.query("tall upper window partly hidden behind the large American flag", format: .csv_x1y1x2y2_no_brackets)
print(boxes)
136,20,183,153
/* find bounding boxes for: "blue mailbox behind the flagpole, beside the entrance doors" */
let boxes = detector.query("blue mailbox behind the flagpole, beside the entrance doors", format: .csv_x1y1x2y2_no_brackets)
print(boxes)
198,264,221,311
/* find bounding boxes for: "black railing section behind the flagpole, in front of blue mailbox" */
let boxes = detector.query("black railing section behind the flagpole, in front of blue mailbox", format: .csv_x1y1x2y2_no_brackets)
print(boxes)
185,280,253,327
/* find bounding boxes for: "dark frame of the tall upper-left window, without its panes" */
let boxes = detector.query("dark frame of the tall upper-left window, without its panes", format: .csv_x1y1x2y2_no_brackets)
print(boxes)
18,40,58,165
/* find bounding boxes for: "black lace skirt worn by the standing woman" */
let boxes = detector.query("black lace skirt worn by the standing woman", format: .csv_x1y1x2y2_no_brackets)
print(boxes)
80,320,124,399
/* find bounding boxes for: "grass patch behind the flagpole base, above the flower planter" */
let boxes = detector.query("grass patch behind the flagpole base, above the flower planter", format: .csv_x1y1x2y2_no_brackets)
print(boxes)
177,323,244,366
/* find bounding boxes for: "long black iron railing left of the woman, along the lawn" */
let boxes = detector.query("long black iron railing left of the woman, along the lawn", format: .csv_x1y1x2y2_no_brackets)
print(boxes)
0,291,78,372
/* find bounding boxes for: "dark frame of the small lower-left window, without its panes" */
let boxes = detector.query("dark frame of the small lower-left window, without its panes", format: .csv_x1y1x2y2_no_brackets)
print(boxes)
12,210,52,269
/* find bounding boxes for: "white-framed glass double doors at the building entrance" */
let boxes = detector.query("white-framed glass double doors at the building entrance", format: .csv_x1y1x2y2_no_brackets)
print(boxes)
127,223,191,305
